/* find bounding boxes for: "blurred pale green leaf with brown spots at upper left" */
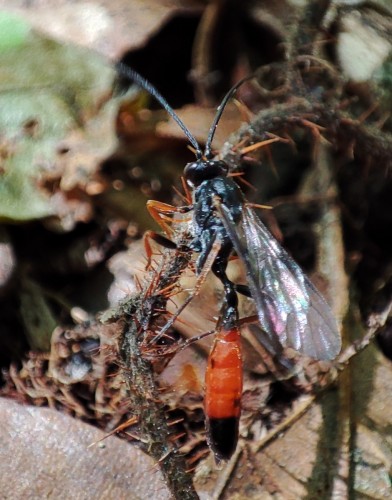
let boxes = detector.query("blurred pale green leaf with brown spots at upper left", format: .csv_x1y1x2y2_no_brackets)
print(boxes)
0,20,114,221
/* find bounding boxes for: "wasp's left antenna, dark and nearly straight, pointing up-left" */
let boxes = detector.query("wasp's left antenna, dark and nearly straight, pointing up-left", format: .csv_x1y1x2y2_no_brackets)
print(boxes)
116,62,203,158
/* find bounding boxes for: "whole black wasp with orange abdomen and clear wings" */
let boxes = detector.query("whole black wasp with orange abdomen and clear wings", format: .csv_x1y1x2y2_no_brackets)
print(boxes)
118,63,341,460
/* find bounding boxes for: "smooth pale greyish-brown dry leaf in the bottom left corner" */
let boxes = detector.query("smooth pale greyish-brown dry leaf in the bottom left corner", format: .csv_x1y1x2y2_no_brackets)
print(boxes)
0,399,170,500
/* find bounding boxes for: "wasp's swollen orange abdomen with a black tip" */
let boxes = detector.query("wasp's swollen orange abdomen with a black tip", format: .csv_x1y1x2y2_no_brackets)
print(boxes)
204,328,242,459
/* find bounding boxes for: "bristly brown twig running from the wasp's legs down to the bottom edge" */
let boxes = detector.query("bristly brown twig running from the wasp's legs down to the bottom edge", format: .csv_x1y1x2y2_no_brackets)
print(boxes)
116,251,198,500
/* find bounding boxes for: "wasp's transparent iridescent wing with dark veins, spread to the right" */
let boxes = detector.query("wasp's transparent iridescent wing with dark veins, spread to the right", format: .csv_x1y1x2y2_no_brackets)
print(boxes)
217,204,341,360
